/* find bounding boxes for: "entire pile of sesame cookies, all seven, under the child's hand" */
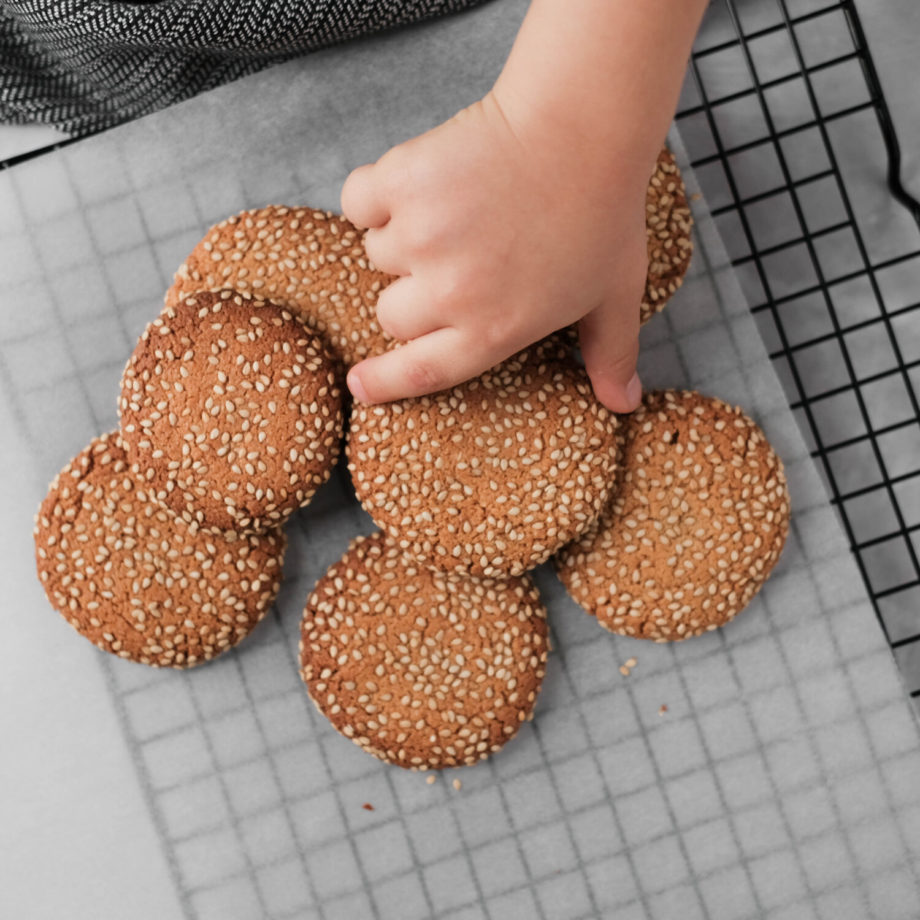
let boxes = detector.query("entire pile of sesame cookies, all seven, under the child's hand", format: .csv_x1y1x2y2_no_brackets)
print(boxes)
35,151,788,769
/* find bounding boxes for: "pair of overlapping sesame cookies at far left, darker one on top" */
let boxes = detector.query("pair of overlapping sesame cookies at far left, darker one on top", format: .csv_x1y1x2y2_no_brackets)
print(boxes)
35,290,343,667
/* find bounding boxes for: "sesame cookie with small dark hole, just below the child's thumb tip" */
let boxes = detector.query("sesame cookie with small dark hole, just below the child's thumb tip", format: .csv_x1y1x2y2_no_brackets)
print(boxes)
555,390,789,641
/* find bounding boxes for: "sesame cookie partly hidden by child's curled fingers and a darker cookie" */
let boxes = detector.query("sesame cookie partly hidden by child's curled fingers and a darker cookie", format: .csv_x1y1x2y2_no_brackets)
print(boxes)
166,205,393,366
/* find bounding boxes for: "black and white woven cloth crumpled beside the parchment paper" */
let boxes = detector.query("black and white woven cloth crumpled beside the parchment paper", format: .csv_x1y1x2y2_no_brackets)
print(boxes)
0,0,482,135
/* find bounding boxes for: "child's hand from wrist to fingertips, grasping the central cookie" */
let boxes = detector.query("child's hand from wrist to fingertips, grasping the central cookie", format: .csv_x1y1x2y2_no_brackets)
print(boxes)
342,93,651,412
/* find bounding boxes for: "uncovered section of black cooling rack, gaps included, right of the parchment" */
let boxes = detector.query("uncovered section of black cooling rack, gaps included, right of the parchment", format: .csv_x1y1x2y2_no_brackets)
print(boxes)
677,0,920,702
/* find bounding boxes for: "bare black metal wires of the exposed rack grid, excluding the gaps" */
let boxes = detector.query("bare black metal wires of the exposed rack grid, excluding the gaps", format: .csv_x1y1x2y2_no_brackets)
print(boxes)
677,0,920,698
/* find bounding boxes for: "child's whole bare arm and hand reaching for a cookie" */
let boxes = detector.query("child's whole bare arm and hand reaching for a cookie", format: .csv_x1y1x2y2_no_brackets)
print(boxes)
342,0,706,412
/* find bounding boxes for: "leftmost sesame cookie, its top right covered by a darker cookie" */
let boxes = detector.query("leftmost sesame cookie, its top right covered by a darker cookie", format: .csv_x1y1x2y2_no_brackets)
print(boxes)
35,432,285,668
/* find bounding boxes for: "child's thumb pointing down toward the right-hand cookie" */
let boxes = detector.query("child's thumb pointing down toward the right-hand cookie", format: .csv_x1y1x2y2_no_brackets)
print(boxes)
578,300,642,412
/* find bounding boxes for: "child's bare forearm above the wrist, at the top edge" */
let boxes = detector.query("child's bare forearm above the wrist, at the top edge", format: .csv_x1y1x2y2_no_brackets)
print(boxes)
494,0,707,182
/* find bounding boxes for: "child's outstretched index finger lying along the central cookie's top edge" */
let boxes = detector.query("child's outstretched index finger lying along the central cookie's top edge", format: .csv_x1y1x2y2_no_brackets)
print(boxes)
347,326,503,404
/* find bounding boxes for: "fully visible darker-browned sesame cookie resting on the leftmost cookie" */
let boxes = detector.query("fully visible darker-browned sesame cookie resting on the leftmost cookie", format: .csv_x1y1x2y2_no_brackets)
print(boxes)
119,291,344,535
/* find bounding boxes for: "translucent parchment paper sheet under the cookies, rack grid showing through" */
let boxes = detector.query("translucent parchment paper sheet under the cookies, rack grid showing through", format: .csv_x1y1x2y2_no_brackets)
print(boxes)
0,2,920,920
